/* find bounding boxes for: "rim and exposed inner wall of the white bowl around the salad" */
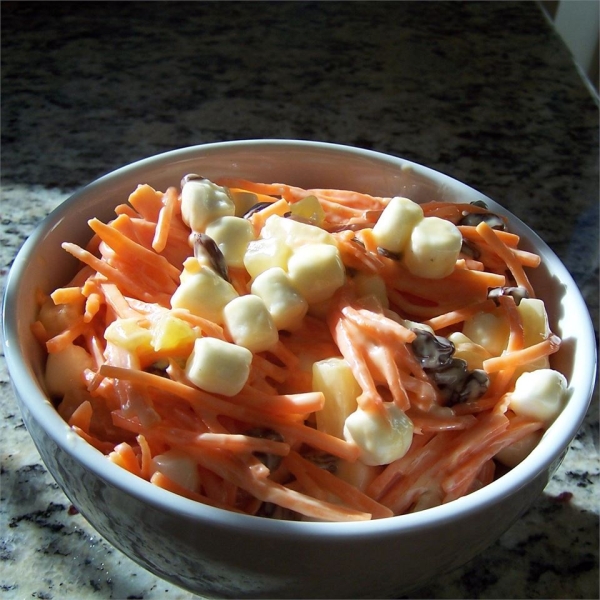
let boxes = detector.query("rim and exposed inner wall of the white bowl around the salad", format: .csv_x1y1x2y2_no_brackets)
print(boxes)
4,140,596,532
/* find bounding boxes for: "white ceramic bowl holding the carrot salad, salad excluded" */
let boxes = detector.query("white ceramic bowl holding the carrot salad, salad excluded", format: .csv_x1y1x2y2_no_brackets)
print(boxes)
4,140,596,598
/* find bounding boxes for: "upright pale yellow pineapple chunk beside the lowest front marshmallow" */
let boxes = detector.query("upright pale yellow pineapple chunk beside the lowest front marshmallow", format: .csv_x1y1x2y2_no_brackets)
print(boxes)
312,358,362,439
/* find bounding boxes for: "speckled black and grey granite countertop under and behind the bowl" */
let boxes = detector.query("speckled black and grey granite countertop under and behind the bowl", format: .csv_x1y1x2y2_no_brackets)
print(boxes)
0,2,600,600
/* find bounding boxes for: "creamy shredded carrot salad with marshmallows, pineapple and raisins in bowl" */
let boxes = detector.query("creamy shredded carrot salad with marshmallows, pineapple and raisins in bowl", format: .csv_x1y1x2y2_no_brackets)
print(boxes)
32,175,567,521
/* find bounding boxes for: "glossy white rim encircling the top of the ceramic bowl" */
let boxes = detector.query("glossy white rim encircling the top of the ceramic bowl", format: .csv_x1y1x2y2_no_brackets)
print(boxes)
2,139,597,538
